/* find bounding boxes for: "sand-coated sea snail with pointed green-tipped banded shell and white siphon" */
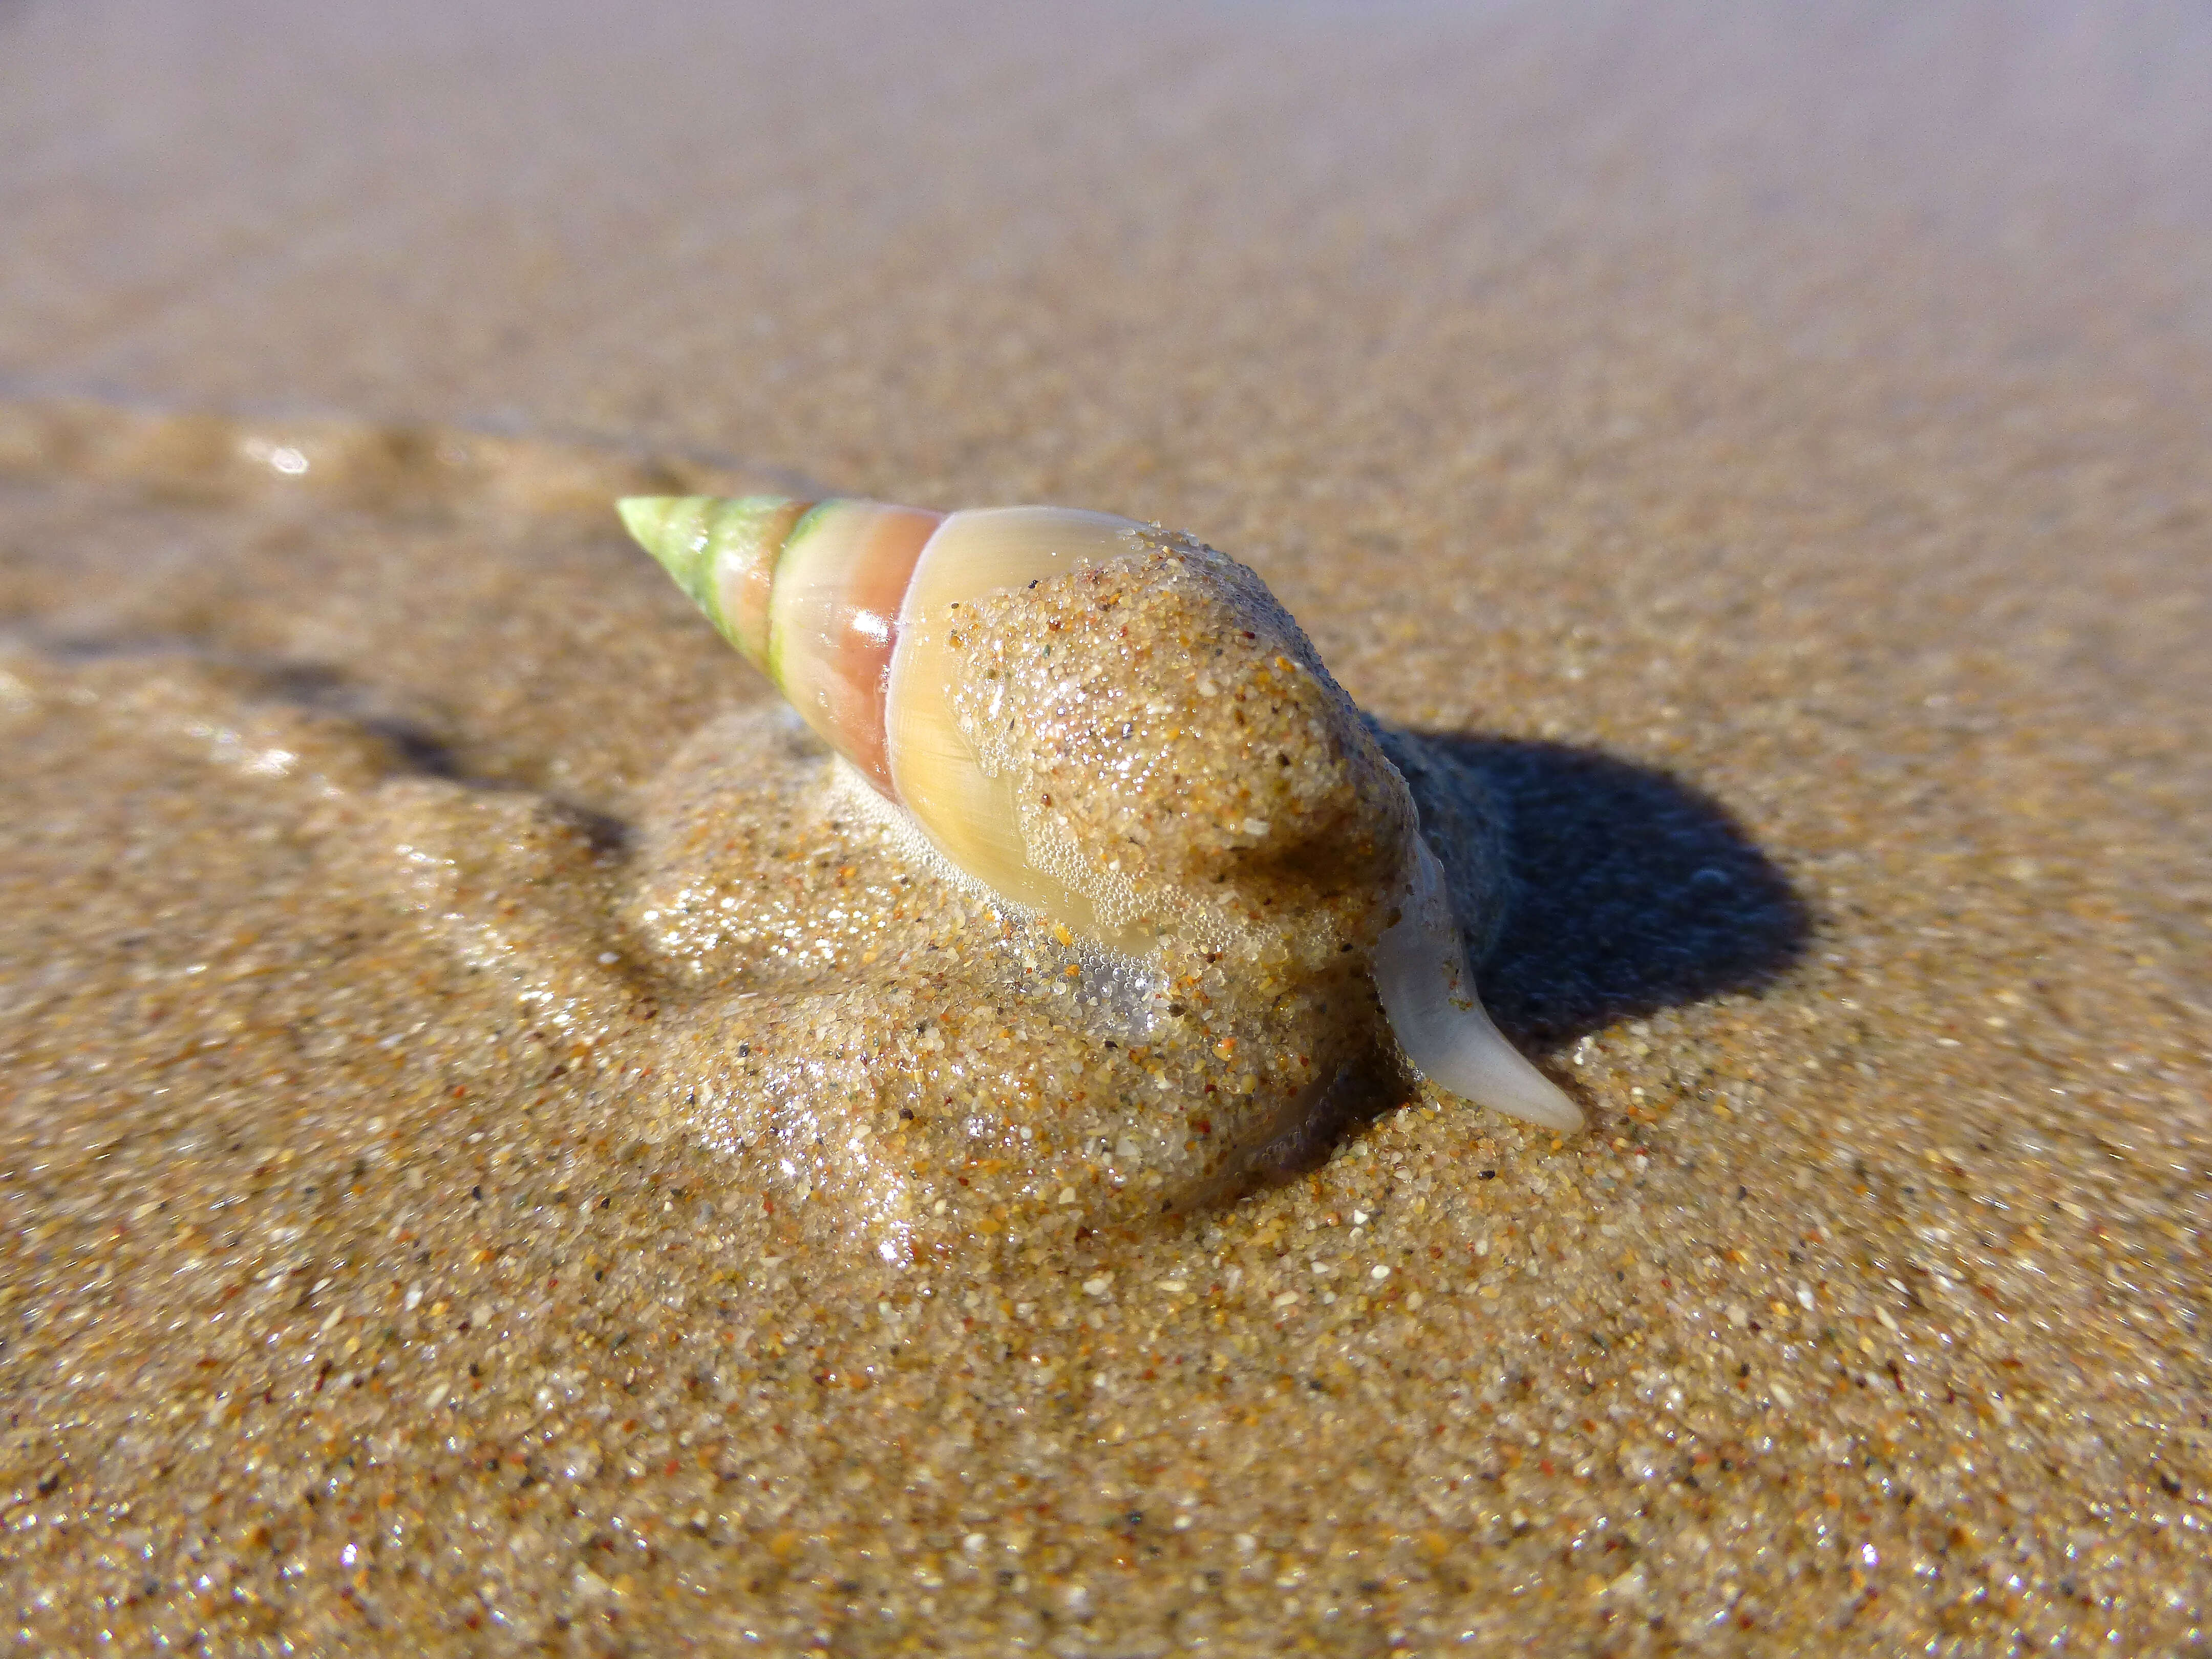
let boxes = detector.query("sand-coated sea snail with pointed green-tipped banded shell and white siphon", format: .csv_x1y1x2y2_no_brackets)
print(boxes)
622,486,1579,1208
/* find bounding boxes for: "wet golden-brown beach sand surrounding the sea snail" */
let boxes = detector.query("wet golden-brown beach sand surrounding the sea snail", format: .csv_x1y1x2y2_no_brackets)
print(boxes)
0,2,2212,1654
